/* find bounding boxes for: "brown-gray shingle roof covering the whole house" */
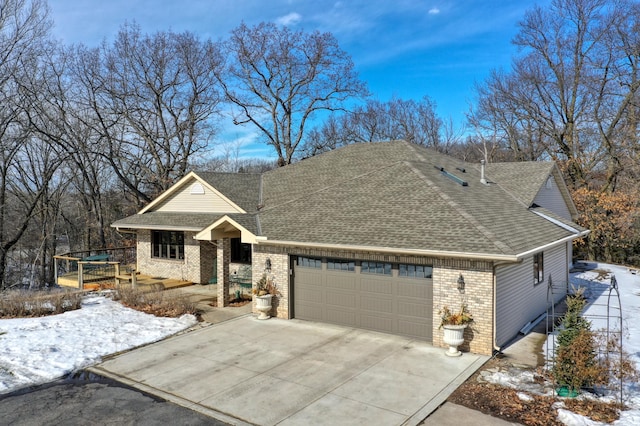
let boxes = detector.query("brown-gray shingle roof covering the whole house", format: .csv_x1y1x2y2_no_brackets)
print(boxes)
114,141,584,256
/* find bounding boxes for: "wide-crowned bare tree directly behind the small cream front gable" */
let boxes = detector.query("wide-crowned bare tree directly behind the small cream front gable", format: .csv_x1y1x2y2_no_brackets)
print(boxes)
70,25,221,207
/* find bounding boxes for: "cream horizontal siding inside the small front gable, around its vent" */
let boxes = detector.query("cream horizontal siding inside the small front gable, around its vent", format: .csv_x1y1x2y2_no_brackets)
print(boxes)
154,179,241,213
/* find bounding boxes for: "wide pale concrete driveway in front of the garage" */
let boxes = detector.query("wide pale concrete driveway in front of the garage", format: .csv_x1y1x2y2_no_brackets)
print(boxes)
92,315,488,425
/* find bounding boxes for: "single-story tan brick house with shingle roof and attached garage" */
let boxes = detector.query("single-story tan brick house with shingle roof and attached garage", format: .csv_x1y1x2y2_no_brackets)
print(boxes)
112,141,588,354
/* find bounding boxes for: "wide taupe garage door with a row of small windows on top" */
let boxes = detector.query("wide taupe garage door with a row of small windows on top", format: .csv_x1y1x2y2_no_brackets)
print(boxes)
292,257,433,342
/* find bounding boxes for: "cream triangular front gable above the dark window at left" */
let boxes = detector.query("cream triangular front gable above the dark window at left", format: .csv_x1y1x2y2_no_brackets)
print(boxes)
151,176,242,213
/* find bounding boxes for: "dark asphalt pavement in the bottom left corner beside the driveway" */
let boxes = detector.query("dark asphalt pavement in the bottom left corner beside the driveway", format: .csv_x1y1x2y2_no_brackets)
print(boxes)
0,375,226,426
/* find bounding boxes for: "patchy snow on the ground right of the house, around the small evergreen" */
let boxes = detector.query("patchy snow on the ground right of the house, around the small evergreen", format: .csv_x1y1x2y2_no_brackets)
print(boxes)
483,263,640,426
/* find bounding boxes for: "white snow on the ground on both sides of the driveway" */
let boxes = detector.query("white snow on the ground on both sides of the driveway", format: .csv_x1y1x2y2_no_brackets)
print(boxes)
0,264,640,426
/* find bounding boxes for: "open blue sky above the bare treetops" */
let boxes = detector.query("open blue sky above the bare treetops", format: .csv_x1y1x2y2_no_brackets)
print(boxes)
49,0,549,160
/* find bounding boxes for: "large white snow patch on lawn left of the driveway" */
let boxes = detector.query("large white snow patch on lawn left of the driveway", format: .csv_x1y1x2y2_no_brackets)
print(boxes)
0,295,196,394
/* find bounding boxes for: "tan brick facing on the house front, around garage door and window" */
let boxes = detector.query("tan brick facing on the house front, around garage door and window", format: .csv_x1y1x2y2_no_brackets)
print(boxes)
137,231,494,355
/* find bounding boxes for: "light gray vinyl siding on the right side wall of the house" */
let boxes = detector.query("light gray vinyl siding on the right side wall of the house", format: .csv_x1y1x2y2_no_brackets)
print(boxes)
496,244,568,346
